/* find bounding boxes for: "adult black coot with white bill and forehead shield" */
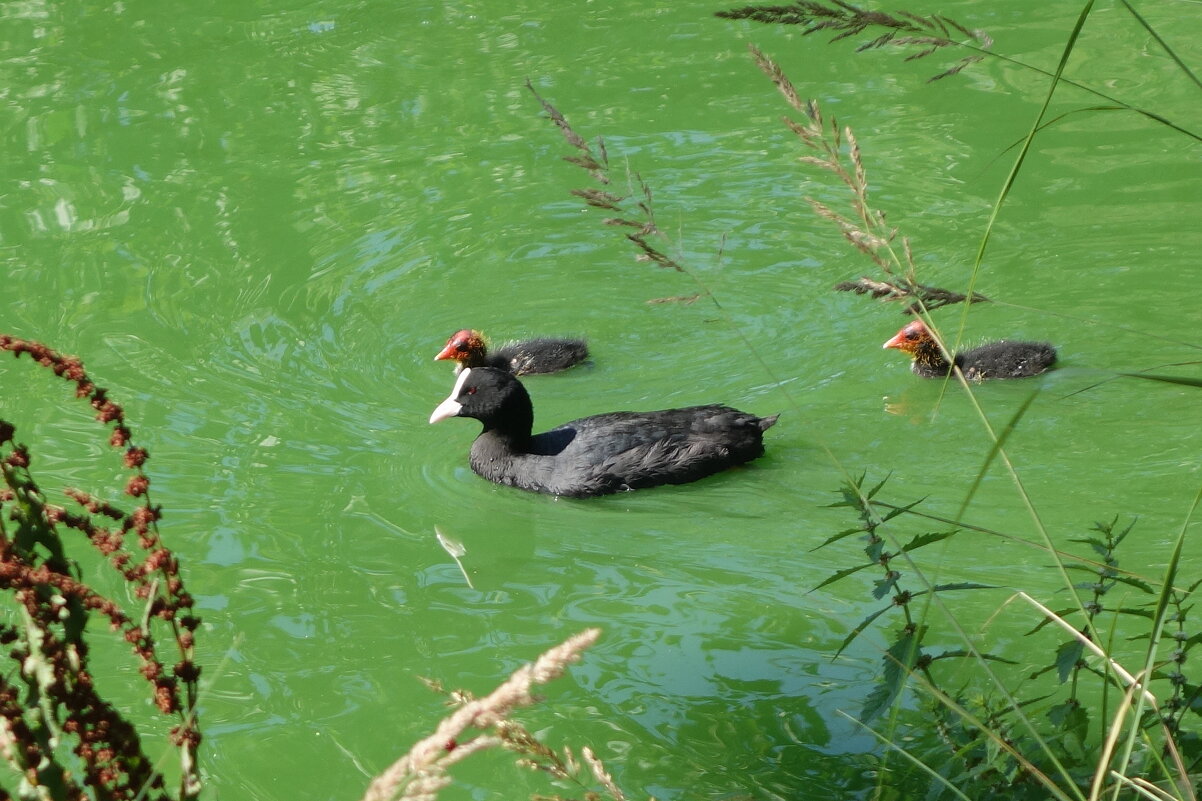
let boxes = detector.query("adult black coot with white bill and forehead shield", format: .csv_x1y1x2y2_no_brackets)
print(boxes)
430,367,776,498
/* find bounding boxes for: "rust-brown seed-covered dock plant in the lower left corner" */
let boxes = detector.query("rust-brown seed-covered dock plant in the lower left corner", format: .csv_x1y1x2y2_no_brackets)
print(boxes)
0,334,201,801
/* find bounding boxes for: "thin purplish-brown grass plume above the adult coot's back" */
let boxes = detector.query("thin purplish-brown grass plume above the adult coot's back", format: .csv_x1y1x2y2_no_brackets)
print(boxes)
525,81,686,273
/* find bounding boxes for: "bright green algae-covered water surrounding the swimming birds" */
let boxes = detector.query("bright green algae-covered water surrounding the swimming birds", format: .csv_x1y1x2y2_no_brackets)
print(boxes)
0,0,1202,801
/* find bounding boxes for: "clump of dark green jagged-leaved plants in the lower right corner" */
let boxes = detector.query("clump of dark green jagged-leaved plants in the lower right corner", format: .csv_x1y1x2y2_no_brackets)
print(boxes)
817,476,1202,801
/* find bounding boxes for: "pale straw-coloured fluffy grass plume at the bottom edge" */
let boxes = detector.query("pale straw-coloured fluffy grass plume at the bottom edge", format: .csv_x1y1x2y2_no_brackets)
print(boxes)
363,629,601,801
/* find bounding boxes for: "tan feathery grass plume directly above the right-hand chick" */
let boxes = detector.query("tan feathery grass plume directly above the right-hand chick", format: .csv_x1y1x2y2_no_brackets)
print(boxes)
749,45,989,314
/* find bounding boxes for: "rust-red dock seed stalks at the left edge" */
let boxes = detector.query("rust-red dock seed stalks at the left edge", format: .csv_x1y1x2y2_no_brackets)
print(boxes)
0,334,201,797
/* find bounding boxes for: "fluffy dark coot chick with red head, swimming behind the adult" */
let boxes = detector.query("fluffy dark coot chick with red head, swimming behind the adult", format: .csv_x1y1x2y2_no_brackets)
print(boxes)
882,320,1055,381
